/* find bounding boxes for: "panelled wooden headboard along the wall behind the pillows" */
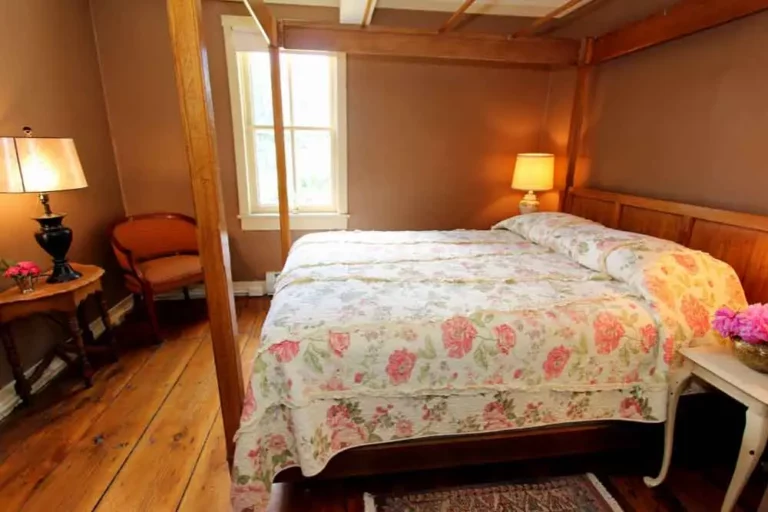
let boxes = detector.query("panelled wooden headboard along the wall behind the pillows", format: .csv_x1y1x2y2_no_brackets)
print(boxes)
564,188,768,302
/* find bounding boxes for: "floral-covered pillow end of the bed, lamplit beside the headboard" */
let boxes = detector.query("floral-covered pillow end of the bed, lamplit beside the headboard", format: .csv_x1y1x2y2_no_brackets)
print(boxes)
494,213,747,368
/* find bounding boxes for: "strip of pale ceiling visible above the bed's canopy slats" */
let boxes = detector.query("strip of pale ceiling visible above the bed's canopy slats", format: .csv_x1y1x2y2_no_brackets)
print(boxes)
266,0,565,16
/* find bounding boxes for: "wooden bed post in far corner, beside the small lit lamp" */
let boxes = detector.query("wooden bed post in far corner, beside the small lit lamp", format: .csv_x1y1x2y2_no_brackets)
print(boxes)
561,37,595,211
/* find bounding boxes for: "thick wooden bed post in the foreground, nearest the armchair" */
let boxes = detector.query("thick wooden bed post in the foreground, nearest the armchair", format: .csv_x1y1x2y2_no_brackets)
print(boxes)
167,0,243,466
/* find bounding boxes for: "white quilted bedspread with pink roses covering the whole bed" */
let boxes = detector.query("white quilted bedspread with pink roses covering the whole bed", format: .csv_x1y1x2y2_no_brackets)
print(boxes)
232,213,746,511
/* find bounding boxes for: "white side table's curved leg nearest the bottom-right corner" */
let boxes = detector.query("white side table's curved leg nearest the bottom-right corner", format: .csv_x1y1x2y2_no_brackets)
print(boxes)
720,405,768,512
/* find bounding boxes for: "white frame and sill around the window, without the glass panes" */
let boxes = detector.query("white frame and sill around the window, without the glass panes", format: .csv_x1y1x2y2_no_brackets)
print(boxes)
221,15,349,231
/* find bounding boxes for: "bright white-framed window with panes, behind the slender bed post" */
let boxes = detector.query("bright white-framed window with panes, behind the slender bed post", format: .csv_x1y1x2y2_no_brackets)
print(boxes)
222,16,348,230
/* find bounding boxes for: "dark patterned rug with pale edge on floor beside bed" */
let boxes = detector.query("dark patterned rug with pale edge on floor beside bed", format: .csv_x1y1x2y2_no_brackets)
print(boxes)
365,473,622,512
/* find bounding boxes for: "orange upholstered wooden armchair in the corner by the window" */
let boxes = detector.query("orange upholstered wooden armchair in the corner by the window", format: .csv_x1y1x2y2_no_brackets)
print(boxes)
109,213,203,343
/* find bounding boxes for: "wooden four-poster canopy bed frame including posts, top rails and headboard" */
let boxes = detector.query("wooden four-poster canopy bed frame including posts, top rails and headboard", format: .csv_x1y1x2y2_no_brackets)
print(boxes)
160,0,768,468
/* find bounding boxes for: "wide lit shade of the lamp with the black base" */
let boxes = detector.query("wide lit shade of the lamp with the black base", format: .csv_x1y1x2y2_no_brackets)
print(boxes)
0,137,88,192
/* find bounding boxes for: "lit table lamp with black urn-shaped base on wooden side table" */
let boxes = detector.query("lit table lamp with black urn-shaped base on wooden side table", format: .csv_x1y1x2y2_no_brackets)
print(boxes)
0,127,88,283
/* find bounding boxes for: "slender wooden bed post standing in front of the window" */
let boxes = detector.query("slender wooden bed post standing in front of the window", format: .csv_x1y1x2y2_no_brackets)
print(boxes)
269,44,295,264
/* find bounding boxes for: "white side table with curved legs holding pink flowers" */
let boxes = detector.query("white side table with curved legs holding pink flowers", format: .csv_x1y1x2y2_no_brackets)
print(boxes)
644,347,768,512
